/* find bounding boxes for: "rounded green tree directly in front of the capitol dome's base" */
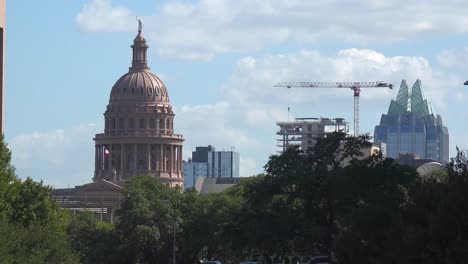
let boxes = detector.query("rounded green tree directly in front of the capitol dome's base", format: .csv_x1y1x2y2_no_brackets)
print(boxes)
117,176,181,263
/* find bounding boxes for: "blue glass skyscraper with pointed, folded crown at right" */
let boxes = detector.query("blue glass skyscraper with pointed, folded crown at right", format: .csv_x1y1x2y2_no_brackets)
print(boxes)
374,80,449,163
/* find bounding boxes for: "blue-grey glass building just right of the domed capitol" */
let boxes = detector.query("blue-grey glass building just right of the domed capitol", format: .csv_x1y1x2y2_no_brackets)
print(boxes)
184,145,239,189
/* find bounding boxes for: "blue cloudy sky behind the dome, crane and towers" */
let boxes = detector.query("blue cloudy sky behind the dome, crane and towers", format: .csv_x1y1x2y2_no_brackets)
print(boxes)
5,0,468,188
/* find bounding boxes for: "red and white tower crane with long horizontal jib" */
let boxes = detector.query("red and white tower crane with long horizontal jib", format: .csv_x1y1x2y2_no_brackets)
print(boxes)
275,82,393,136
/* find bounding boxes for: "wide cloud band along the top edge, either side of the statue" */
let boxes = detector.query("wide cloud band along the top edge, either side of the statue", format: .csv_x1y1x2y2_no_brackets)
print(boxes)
76,0,468,61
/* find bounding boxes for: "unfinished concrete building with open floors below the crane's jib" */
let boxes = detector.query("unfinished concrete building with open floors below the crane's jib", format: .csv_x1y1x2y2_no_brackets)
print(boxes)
276,117,349,153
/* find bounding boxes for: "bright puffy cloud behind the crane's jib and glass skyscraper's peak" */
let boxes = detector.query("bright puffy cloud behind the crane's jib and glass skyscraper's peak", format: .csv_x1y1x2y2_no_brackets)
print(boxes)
223,49,458,107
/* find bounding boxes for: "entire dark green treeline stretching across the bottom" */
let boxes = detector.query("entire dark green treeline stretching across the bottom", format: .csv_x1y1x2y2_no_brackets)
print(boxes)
0,133,468,264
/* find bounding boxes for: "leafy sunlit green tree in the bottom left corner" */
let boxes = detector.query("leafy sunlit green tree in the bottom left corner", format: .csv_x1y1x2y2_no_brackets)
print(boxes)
0,136,78,263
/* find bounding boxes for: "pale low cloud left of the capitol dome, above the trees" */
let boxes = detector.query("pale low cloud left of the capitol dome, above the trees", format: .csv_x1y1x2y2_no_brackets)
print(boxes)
8,124,99,187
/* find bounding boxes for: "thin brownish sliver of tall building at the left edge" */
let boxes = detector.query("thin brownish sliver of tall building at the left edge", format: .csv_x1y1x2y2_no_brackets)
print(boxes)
0,0,6,133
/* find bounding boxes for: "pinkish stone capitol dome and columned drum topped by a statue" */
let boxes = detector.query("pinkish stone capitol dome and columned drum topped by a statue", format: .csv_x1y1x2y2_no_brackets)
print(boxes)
93,25,184,188
